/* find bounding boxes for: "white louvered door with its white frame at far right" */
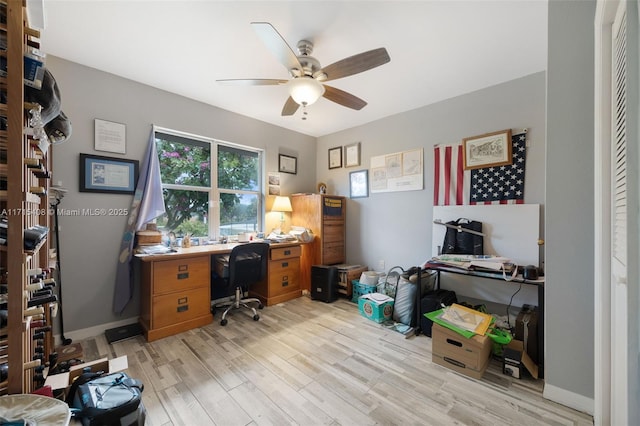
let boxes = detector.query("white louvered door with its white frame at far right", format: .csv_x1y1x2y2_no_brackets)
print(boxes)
594,0,631,425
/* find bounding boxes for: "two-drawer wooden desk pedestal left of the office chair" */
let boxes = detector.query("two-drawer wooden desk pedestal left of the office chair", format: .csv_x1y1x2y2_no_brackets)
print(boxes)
137,254,213,341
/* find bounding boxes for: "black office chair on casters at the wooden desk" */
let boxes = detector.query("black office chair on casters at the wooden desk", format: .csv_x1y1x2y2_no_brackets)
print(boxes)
214,243,269,326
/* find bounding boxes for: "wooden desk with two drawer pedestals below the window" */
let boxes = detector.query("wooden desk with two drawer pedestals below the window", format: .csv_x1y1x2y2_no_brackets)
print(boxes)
135,243,302,341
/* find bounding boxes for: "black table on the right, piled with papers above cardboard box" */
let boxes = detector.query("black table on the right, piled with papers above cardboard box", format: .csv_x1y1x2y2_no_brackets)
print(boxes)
418,263,544,378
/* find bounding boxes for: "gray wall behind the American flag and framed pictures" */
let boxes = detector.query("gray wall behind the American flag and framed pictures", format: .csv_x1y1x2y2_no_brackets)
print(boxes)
316,72,545,269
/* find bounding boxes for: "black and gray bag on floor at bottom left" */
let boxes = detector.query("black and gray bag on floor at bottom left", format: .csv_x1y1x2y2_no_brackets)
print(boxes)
66,372,146,426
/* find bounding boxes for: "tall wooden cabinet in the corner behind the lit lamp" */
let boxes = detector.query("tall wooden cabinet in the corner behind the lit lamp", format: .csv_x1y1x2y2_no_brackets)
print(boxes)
291,194,347,290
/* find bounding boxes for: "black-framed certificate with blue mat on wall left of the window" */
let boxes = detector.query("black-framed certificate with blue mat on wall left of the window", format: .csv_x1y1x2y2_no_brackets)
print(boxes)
80,154,138,194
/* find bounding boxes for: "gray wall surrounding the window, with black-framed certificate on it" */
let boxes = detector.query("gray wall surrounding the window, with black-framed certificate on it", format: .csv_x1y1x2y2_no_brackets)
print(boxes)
47,56,316,331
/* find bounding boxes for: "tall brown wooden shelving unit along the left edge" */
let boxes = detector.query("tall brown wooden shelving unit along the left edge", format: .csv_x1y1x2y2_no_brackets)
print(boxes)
0,0,53,395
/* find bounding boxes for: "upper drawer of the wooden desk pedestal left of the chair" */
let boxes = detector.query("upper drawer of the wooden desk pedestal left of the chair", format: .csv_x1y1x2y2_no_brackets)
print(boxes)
153,255,211,295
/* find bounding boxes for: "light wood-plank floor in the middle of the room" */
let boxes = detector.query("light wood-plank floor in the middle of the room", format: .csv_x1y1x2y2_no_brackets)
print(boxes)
81,297,593,426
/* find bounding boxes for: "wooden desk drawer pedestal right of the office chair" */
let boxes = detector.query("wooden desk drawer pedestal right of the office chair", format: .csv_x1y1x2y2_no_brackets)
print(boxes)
249,244,302,306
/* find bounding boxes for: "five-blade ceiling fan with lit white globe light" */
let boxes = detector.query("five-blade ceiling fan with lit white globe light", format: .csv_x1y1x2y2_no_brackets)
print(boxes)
217,22,391,119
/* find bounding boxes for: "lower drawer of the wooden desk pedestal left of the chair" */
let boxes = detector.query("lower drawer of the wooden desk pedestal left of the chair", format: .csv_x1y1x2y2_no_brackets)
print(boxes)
151,287,211,329
